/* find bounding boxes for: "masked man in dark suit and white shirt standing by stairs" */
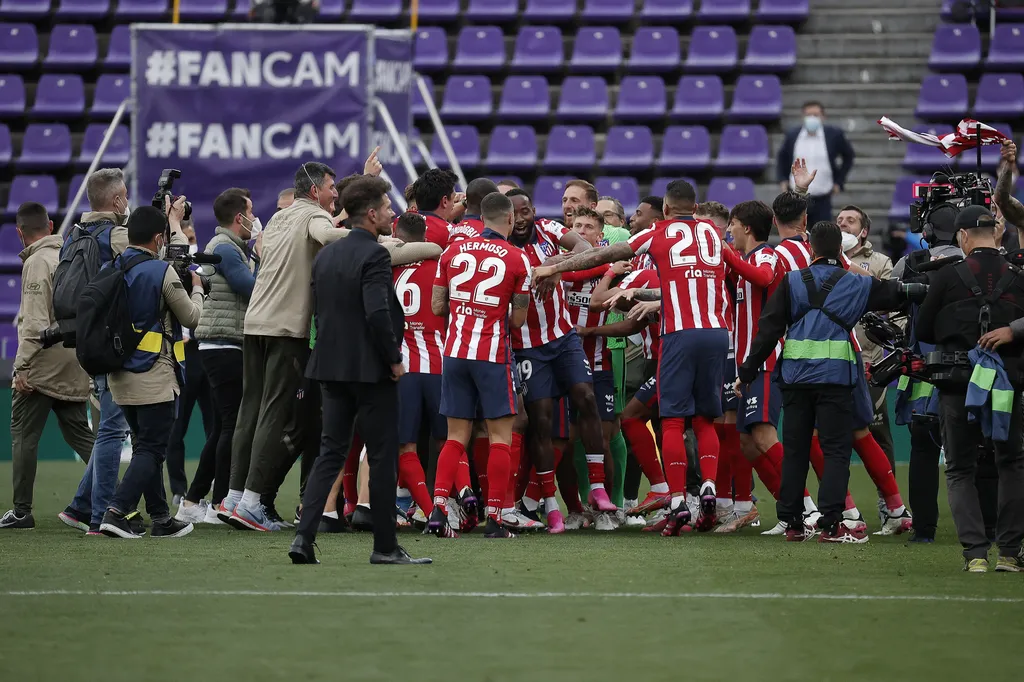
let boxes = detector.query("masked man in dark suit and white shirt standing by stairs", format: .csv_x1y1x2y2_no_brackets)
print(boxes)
775,101,854,225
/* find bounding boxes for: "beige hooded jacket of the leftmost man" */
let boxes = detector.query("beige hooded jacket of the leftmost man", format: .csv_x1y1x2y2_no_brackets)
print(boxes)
14,235,89,402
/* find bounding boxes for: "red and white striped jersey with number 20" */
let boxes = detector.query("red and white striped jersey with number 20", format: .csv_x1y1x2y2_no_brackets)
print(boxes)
629,216,729,334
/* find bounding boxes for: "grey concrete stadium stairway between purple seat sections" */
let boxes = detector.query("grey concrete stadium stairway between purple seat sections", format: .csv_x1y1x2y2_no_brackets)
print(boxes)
770,0,942,232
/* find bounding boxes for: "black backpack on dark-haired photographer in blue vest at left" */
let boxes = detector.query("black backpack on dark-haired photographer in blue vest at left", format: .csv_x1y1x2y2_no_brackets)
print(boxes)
75,254,153,377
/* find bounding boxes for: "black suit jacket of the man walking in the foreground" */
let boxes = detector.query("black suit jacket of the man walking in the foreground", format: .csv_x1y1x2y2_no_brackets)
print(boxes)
306,229,406,383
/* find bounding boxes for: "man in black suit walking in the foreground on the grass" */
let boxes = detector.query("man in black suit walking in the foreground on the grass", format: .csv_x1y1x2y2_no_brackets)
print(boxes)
288,177,430,564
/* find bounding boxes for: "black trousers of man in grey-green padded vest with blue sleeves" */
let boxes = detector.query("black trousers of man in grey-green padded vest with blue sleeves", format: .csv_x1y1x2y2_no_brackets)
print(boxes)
185,348,242,504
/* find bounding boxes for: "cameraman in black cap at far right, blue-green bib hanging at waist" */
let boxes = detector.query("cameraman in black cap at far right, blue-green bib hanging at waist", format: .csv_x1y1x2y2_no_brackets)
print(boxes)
915,206,1024,572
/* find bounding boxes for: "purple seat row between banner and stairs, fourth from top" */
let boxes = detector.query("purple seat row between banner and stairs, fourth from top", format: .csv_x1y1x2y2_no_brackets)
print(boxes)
421,125,770,173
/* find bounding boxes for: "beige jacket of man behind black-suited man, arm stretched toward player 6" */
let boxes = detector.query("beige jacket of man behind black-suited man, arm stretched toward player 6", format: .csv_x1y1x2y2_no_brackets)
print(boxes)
245,197,441,339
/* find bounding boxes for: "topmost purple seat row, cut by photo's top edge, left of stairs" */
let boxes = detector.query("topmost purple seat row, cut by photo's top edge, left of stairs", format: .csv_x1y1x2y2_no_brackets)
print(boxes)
0,0,810,23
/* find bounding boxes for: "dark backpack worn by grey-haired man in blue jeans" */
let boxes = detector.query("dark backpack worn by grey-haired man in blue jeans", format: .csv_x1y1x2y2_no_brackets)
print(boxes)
53,221,114,348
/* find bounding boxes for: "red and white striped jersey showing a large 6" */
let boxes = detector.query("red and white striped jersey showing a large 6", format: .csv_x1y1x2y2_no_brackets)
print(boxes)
391,260,446,374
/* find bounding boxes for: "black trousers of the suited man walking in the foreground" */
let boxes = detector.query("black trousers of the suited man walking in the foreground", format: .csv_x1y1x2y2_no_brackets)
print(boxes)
297,381,398,552
